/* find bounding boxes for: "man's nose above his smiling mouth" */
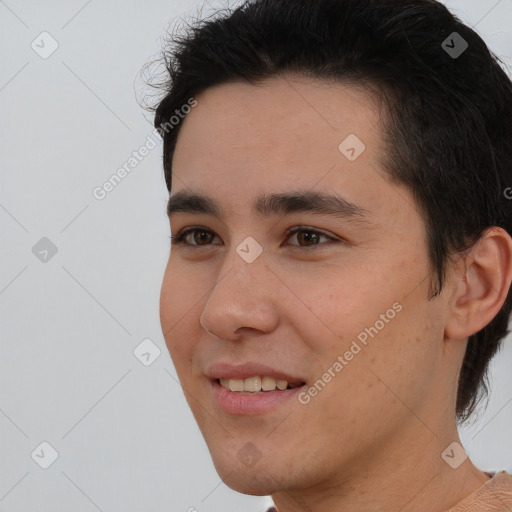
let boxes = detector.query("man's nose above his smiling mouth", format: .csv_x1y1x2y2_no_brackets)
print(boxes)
200,250,283,340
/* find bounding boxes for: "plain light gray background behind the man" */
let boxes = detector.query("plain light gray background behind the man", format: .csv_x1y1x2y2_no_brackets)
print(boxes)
0,0,512,512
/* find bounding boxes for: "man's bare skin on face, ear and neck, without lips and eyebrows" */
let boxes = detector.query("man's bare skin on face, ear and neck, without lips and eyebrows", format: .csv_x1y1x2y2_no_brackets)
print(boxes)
160,76,512,512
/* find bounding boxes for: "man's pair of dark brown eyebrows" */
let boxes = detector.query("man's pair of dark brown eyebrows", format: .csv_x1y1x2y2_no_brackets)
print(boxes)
167,190,371,224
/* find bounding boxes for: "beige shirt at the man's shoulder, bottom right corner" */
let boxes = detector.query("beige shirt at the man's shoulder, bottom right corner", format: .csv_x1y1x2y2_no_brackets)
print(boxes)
267,471,512,512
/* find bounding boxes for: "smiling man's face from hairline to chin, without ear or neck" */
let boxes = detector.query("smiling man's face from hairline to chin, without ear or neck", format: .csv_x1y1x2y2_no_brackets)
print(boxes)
161,77,452,495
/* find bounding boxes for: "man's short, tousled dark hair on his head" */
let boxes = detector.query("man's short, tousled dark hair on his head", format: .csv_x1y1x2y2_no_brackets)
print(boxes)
153,0,512,422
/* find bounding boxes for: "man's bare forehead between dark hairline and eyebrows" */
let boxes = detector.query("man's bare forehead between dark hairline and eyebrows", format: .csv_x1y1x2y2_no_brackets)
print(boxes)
172,76,412,228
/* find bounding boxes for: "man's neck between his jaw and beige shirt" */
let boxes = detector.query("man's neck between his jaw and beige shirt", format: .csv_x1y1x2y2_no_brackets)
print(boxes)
272,416,489,512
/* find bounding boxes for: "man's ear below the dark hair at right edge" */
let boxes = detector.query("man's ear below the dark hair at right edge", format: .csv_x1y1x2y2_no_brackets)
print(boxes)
445,227,512,339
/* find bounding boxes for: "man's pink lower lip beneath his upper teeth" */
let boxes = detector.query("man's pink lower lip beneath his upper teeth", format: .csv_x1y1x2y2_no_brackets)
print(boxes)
210,380,305,414
